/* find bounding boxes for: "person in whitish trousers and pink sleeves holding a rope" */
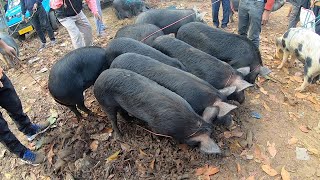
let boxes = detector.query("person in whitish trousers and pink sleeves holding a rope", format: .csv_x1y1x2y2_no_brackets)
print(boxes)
50,0,101,49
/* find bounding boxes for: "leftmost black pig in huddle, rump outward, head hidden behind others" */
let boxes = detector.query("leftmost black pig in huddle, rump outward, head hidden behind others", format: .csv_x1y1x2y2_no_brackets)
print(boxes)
48,46,109,119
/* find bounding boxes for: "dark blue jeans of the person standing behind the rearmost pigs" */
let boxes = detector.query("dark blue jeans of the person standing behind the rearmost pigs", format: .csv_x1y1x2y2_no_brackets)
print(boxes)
211,0,231,28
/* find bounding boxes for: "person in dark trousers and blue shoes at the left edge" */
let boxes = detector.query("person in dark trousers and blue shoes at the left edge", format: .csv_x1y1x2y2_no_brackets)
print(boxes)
0,39,50,165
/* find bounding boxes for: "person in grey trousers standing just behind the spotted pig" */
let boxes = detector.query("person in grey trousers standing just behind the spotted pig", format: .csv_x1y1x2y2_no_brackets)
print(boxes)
288,0,311,29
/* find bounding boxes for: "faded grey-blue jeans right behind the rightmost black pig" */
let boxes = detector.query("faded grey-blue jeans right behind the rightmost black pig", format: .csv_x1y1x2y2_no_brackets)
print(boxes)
238,0,265,48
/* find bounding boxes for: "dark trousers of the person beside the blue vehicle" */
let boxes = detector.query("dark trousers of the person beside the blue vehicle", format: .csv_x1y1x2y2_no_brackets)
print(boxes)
31,5,55,43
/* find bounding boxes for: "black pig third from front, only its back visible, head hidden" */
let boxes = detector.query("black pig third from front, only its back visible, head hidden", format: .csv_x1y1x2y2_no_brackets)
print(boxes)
106,37,185,70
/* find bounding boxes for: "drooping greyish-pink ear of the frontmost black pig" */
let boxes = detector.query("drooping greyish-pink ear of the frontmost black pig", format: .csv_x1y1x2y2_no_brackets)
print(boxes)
191,134,221,154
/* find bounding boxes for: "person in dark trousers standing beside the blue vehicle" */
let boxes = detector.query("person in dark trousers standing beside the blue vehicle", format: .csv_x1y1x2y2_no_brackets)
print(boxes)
21,0,56,51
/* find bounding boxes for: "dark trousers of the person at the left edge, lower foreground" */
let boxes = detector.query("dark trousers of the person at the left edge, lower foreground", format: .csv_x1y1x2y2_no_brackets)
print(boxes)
0,74,32,158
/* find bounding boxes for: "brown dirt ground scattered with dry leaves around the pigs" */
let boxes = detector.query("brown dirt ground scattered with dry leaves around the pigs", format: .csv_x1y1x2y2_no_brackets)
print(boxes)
0,0,320,180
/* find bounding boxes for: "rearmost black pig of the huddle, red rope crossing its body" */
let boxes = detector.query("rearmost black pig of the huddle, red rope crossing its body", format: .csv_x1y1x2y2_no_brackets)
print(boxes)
135,8,205,34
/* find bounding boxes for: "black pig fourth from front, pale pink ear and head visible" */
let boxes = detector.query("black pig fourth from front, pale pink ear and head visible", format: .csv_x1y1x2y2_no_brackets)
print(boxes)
153,35,252,103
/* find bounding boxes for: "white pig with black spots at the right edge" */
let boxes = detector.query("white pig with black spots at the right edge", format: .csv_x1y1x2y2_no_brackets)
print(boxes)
275,28,320,91
